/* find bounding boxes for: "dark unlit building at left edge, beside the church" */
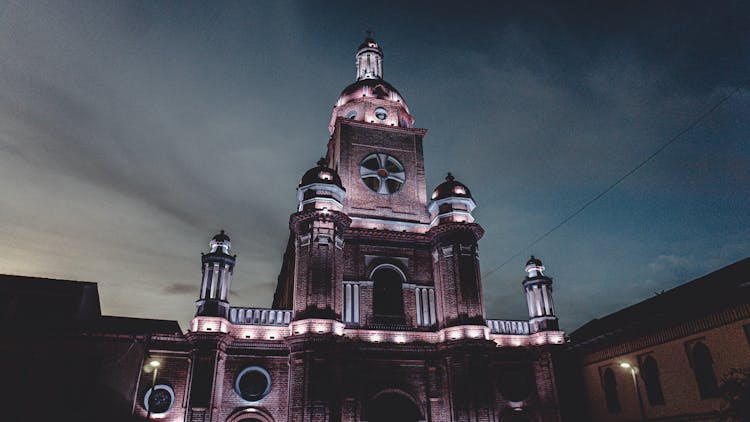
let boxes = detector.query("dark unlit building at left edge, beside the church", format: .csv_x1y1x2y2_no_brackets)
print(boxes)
0,275,183,422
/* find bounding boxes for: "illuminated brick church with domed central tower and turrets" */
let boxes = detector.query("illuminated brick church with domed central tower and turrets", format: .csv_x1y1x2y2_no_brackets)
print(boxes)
138,38,564,422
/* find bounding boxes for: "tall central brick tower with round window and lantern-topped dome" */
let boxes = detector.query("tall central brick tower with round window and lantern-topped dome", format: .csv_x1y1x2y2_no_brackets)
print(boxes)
326,37,429,232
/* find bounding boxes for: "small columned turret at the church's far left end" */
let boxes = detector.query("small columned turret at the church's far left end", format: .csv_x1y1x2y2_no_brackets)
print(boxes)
195,230,237,318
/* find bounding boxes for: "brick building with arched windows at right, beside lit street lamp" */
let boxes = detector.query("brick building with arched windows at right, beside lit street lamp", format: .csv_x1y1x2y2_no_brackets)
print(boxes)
568,258,750,421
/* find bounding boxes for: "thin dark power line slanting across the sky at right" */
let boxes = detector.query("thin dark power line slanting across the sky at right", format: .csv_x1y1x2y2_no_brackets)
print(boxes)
482,81,750,279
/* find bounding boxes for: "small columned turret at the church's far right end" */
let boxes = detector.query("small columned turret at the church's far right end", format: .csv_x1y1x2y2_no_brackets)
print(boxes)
523,255,559,333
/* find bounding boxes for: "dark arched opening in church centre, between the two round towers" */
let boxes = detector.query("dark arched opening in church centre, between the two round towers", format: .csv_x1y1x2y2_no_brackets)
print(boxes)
372,265,404,324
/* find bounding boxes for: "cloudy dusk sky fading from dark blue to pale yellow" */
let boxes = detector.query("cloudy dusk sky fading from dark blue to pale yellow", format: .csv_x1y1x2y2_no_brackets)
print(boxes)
0,1,750,330
